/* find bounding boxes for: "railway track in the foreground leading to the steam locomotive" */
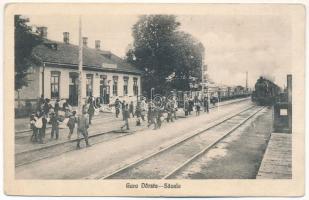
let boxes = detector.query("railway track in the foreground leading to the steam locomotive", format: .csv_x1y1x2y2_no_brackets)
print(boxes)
100,106,264,179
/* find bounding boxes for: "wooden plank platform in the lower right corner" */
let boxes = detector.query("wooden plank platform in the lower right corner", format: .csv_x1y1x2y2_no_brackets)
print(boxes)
256,133,292,179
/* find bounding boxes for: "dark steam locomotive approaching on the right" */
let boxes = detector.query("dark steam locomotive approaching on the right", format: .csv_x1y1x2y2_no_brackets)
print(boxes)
251,77,281,106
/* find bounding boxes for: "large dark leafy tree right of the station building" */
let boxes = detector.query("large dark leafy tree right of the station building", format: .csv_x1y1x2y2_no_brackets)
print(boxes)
127,15,204,95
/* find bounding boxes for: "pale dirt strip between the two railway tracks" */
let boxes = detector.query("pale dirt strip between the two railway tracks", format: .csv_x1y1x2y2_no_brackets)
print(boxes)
15,100,252,179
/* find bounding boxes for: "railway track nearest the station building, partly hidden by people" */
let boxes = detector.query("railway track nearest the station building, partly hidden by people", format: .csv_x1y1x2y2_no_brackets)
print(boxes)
15,99,247,167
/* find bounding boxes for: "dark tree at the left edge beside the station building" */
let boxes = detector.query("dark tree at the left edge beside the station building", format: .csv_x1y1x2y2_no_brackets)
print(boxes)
14,15,42,91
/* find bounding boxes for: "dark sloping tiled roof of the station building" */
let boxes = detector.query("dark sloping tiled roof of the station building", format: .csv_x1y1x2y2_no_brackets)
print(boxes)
33,40,141,73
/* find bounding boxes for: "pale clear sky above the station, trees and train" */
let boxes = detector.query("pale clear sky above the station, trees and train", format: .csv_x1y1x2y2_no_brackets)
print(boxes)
27,15,292,87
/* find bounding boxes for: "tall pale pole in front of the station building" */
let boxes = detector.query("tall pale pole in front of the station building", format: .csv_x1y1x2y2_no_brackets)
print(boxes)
78,16,83,115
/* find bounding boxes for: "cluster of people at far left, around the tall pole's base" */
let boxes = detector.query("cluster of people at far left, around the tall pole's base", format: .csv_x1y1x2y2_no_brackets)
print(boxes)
30,96,97,148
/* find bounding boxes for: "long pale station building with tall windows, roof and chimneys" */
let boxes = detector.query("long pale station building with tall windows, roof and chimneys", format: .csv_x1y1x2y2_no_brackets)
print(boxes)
15,27,141,109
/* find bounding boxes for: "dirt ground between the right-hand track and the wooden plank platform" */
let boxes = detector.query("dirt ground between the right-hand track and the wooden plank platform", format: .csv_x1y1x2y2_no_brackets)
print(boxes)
175,108,272,179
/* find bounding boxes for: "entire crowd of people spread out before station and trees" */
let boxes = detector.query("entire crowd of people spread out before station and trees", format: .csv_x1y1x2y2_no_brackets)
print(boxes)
30,96,209,149
